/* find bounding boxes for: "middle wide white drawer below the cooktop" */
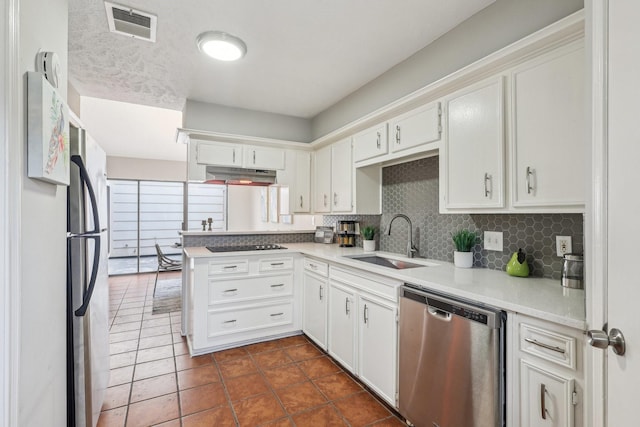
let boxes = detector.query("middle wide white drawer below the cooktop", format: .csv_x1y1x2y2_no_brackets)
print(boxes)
209,274,293,305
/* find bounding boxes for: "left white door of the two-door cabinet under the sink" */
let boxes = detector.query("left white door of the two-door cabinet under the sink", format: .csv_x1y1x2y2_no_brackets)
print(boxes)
328,283,357,372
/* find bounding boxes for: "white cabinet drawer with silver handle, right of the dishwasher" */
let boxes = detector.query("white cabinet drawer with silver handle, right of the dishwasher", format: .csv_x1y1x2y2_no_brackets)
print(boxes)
520,323,576,370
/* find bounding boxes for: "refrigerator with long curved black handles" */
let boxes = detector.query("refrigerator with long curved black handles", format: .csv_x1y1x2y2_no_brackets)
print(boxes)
67,125,109,427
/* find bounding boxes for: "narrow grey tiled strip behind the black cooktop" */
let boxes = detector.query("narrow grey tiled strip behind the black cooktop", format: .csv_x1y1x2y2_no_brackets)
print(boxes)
182,233,314,248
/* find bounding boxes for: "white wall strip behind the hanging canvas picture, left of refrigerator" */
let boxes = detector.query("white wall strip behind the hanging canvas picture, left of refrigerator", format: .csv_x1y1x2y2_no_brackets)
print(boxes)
16,0,68,426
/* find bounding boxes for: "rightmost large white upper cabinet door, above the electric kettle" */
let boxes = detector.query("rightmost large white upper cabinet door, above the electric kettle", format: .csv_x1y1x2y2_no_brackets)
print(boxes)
512,42,588,207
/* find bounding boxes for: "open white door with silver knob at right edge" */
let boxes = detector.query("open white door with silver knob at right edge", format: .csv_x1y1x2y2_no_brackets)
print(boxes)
591,0,640,427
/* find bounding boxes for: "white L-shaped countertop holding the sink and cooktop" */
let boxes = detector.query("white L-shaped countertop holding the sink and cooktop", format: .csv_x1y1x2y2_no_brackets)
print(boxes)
184,243,586,330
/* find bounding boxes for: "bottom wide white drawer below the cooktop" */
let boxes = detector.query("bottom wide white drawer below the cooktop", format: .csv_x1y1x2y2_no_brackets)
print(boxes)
207,301,293,338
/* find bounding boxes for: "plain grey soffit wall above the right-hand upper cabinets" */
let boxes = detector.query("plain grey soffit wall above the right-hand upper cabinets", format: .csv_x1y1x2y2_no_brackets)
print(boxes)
311,0,583,139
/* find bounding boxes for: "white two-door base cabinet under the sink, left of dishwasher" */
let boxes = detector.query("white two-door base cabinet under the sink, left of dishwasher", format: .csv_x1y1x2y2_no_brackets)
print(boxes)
328,266,400,407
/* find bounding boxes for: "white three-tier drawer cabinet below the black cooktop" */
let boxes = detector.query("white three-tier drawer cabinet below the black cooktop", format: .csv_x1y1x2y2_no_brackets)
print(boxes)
183,255,301,355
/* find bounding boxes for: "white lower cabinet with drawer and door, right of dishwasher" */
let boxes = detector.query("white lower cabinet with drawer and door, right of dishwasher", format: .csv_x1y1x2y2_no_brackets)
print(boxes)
507,314,585,427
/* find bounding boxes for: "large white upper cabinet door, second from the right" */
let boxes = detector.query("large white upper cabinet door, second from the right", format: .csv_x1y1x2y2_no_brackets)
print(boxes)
444,77,504,208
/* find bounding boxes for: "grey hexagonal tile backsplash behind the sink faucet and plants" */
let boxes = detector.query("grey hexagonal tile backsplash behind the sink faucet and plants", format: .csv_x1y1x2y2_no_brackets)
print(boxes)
324,157,584,279
